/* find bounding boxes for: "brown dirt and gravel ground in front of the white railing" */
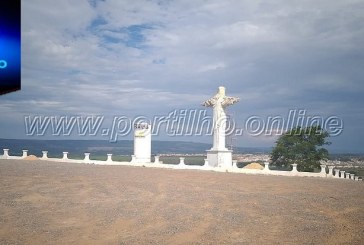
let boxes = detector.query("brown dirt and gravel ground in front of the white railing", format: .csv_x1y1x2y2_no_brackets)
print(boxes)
0,160,364,244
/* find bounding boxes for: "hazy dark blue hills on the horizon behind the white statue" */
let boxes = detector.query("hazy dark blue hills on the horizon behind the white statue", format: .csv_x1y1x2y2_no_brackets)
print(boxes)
0,139,271,157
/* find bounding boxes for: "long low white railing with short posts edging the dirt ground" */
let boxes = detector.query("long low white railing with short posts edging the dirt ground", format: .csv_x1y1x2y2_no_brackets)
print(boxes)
0,149,362,180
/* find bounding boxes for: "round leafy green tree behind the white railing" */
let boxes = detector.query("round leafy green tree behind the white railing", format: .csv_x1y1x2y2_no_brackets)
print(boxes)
271,126,331,172
